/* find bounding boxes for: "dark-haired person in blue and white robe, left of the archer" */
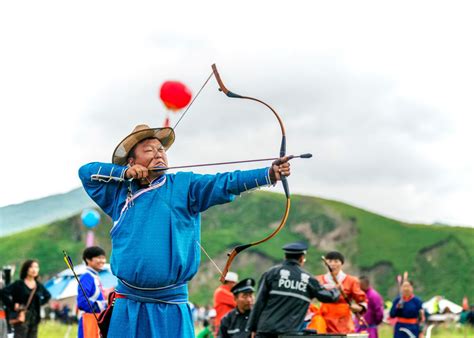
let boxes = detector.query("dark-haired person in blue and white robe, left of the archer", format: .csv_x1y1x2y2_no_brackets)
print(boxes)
77,246,107,338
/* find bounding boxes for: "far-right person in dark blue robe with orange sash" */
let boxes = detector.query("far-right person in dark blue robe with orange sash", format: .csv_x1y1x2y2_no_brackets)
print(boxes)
390,280,425,338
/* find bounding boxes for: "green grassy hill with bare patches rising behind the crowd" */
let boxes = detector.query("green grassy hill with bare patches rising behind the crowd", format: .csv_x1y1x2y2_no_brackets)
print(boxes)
0,192,474,303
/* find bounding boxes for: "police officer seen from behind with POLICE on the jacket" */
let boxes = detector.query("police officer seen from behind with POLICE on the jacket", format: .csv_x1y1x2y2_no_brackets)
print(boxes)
247,243,340,337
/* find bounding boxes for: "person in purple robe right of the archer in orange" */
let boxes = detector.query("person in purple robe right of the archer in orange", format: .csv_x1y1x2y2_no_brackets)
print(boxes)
356,276,383,338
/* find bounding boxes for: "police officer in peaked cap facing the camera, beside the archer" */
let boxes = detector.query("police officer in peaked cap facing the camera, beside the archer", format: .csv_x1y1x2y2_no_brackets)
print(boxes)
219,278,255,338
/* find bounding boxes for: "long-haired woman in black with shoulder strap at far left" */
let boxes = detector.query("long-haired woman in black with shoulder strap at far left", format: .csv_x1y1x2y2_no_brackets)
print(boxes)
1,259,51,338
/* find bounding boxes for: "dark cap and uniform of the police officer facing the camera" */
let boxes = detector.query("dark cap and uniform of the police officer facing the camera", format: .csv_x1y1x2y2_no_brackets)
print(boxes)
218,278,255,338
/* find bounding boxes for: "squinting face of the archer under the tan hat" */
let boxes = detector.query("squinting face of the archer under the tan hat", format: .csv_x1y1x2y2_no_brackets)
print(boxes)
128,138,168,168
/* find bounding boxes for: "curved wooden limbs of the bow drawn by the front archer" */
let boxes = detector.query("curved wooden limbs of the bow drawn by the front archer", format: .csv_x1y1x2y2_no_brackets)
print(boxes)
212,64,291,283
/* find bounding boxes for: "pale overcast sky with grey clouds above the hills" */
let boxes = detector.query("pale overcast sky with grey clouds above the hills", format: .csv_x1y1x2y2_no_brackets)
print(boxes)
0,0,474,226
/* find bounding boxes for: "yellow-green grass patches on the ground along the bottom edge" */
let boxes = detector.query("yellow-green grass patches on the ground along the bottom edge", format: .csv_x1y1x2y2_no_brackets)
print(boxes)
38,321,474,338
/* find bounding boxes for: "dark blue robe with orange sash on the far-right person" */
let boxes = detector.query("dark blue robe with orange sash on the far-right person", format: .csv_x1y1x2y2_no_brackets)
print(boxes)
390,296,423,338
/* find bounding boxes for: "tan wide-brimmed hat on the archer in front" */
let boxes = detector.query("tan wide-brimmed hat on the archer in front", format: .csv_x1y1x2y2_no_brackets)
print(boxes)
112,124,175,165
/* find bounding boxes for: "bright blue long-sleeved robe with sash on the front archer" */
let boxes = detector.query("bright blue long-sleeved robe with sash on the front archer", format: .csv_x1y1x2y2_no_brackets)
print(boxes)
79,163,271,338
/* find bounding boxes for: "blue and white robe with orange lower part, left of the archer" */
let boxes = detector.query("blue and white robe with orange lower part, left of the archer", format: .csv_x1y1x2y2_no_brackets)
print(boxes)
77,267,107,338
